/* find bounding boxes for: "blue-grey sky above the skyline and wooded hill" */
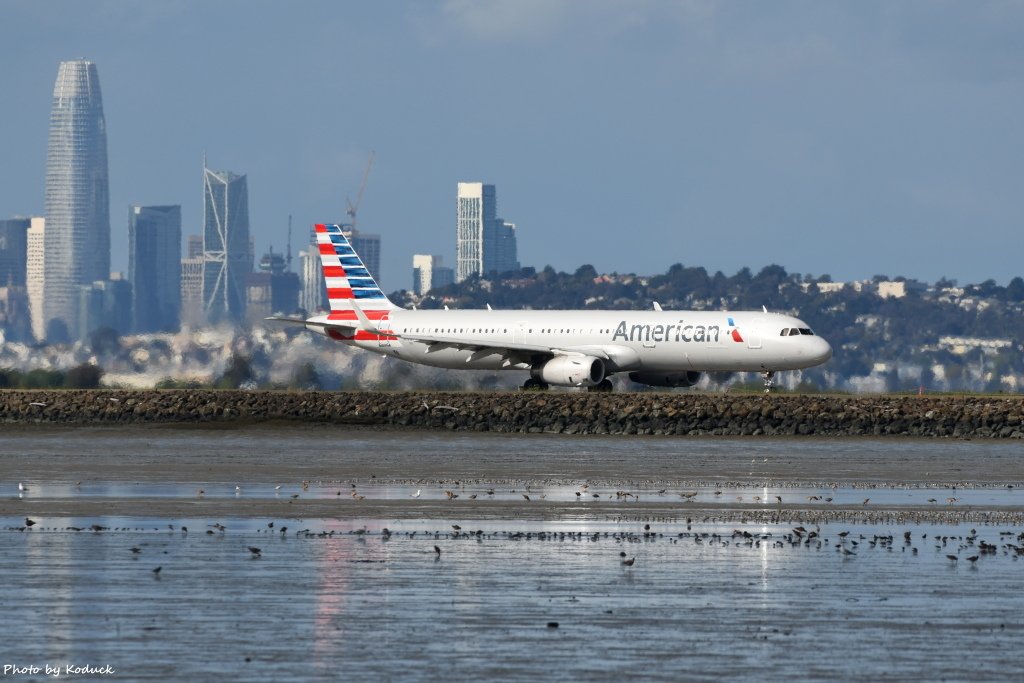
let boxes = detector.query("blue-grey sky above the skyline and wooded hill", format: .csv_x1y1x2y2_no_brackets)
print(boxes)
0,0,1024,291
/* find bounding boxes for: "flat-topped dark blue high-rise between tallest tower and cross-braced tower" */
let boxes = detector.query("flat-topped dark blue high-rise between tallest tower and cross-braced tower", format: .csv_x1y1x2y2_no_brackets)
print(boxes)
128,205,181,332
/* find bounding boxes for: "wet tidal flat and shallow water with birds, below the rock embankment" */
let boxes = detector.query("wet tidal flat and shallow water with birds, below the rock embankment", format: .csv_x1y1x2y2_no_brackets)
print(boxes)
0,427,1024,681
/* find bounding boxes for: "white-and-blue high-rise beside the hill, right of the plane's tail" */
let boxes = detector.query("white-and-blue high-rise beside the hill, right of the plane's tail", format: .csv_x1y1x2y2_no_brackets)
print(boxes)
455,182,519,283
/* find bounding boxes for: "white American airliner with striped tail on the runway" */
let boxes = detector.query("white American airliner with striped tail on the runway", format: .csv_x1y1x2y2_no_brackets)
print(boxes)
266,223,831,392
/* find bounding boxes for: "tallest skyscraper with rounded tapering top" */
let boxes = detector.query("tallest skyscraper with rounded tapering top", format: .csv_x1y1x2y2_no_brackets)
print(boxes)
42,59,111,336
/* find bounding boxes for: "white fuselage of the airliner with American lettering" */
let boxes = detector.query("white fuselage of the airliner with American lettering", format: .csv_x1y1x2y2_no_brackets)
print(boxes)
309,309,831,373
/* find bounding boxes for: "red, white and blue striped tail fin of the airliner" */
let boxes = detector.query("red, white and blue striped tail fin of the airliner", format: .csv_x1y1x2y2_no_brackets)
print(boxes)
313,223,398,319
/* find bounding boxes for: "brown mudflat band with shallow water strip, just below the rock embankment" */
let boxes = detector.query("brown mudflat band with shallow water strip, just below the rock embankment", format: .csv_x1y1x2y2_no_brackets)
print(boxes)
0,424,1024,521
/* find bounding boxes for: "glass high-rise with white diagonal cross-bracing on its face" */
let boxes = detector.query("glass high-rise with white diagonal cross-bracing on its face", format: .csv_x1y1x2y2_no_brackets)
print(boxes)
203,165,253,323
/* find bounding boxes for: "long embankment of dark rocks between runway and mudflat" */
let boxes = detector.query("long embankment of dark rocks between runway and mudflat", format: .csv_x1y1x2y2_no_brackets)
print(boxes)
0,390,1024,439
